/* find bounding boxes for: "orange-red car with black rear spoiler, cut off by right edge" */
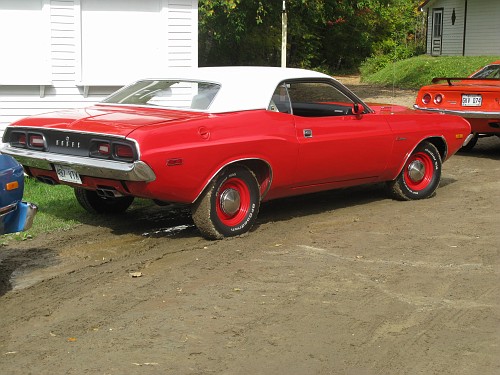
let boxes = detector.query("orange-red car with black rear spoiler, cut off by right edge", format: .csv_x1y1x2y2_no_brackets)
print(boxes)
414,61,500,150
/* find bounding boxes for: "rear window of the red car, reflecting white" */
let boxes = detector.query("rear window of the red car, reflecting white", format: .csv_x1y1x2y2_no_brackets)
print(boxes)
102,80,220,110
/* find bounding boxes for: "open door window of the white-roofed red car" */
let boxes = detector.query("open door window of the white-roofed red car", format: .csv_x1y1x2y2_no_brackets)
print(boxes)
287,81,354,117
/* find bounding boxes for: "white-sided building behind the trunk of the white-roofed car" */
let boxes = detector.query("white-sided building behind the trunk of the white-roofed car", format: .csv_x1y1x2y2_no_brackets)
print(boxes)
0,0,198,136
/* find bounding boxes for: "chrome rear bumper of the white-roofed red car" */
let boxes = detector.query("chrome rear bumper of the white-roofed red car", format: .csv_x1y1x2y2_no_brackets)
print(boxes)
2,146,156,182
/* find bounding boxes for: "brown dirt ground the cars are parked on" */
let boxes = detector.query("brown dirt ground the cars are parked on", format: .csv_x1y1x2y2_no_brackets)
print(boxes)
0,77,500,375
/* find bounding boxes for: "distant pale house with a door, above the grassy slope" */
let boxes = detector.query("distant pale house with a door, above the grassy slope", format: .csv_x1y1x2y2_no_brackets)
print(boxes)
420,0,500,56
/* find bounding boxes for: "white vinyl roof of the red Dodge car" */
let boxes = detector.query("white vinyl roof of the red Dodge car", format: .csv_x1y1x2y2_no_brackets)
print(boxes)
143,66,333,113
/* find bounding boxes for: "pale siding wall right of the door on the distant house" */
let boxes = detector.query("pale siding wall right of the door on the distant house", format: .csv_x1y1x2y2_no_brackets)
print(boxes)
465,0,500,56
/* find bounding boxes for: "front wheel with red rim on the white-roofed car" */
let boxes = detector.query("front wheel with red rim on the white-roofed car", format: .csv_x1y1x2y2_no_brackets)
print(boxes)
388,142,442,201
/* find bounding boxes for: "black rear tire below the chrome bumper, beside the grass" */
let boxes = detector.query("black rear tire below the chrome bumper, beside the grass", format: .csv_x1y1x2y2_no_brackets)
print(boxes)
75,188,134,214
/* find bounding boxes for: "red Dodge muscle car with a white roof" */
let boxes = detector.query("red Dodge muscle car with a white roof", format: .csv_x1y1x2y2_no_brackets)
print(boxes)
2,67,470,239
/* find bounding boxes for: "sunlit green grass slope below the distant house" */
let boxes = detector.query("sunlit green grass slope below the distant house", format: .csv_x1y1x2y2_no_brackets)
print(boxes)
360,55,500,89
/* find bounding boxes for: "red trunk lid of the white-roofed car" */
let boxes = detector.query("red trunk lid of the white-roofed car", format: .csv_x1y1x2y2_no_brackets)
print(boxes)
14,105,207,137
